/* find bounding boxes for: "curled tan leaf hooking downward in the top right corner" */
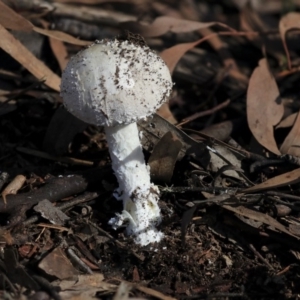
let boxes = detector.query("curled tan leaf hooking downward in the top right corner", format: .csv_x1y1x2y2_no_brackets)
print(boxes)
279,12,300,69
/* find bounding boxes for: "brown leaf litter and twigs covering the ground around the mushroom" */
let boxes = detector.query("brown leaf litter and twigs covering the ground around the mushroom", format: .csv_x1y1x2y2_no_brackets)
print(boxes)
0,0,300,300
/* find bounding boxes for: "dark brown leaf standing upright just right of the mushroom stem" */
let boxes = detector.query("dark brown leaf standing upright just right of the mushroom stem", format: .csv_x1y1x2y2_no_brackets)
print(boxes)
148,131,182,183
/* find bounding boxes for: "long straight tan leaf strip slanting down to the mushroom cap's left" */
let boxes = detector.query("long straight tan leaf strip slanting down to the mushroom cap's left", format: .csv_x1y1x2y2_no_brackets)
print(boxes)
0,25,60,91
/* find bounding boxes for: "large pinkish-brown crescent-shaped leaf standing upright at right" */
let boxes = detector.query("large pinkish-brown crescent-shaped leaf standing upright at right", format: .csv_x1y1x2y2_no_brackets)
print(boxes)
247,58,284,155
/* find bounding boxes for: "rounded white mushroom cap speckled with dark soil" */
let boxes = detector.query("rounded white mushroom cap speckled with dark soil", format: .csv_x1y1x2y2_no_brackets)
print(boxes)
61,40,173,126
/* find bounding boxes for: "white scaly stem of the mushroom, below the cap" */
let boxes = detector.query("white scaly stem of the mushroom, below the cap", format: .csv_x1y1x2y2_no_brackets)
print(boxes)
105,123,163,245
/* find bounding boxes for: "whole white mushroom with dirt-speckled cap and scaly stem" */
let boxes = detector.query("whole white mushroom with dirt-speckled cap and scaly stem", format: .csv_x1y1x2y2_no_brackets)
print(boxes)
61,40,173,245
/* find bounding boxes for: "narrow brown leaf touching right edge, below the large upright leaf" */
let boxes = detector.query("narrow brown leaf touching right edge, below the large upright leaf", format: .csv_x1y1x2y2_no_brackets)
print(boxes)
243,168,300,193
